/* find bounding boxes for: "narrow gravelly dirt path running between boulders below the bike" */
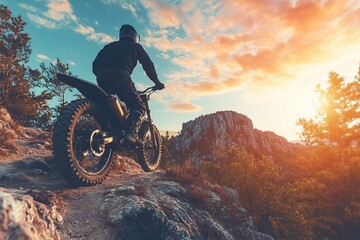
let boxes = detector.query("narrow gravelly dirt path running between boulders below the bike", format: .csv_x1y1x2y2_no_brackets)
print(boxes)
56,170,162,239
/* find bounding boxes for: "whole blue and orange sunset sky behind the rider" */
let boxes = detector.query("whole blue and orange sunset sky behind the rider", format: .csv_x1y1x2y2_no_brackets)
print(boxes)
0,0,360,140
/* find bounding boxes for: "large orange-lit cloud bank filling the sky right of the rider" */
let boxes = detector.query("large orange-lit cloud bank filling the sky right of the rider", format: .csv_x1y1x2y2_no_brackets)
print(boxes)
141,0,360,111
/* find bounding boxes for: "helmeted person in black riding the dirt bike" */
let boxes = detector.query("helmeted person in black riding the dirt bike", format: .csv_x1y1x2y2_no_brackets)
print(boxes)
93,24,165,142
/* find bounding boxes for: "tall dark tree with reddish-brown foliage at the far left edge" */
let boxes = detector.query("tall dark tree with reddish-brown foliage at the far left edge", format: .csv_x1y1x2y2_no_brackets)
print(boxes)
0,5,50,125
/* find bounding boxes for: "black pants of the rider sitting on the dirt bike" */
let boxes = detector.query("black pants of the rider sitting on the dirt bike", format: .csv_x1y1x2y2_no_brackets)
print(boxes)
96,72,146,115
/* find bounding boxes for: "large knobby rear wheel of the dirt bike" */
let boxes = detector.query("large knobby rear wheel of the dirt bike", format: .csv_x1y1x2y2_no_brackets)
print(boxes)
53,99,113,186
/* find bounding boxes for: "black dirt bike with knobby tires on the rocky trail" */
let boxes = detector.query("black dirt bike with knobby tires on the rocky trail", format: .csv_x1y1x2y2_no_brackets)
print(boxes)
53,74,161,186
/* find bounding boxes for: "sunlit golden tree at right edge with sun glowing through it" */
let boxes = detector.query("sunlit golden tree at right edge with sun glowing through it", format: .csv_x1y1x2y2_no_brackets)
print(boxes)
297,66,360,147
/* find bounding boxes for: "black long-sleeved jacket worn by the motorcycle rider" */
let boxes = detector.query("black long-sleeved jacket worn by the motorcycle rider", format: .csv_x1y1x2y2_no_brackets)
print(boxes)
93,39,159,83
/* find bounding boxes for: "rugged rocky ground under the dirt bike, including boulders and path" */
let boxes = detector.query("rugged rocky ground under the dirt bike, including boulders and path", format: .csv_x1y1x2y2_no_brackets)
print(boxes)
0,132,271,239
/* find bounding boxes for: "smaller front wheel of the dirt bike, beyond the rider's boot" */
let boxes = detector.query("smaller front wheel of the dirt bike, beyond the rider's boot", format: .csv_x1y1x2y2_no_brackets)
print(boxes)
137,122,161,172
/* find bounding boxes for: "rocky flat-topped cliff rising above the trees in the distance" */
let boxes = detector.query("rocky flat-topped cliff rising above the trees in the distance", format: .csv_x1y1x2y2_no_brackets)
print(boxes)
175,111,295,160
